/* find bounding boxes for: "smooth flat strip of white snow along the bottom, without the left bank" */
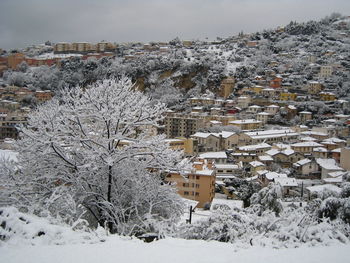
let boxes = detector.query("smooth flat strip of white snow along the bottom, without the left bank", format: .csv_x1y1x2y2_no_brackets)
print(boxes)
0,236,350,263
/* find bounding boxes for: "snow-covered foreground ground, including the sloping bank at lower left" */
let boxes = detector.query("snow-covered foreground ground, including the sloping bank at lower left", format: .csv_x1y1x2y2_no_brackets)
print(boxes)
0,208,350,263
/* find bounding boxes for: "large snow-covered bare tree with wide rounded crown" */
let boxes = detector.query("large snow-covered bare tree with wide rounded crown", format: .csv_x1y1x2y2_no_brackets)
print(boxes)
17,77,186,235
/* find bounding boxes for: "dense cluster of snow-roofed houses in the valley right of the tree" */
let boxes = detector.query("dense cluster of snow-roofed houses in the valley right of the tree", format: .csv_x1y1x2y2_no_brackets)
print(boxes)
164,78,350,207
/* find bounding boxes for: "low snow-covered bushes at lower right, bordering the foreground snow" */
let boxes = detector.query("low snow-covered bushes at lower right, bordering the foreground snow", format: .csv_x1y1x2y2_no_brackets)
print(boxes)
178,203,350,248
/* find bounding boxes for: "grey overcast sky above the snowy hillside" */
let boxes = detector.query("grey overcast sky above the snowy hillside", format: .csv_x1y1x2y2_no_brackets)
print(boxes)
0,0,350,49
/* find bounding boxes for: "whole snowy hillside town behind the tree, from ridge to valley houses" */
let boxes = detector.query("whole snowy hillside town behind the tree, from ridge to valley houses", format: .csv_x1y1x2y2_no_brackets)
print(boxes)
0,14,350,212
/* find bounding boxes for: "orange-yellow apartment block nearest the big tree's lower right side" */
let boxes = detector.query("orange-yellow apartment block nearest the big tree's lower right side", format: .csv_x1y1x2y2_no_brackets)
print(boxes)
165,159,216,208
